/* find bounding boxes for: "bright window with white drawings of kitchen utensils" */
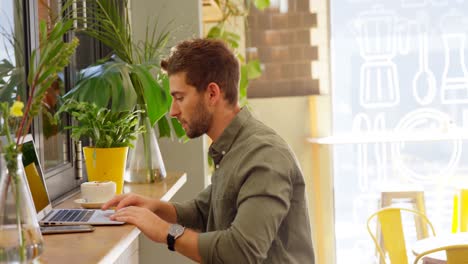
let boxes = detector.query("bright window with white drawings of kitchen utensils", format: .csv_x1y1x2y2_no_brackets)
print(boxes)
330,0,468,263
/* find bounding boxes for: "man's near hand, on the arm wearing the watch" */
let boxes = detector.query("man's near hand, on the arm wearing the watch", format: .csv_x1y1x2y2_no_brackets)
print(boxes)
110,206,169,243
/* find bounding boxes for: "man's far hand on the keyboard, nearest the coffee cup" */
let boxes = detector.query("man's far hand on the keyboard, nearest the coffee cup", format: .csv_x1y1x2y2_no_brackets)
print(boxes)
101,193,159,212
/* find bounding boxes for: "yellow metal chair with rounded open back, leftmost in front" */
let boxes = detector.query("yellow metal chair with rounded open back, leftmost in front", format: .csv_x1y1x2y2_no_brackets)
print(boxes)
367,207,435,264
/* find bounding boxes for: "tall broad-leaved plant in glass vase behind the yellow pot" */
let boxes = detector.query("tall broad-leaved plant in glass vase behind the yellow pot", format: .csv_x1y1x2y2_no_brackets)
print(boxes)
58,0,185,182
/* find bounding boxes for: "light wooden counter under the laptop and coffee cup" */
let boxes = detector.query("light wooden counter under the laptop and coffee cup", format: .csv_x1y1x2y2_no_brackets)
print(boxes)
39,172,187,264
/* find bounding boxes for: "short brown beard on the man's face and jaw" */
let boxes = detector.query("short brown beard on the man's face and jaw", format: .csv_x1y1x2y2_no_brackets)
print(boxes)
185,100,213,138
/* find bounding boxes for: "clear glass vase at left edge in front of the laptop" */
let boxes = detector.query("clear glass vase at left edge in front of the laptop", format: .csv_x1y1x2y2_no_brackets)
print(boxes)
0,154,44,263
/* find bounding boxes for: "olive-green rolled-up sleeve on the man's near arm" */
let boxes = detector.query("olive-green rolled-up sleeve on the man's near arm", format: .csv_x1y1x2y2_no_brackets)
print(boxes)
198,160,292,264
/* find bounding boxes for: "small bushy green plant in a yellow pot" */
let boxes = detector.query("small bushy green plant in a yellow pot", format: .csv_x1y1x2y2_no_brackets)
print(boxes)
55,100,144,194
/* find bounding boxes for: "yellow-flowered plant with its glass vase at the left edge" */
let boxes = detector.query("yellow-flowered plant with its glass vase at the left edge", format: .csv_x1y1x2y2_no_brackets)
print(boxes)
0,16,78,263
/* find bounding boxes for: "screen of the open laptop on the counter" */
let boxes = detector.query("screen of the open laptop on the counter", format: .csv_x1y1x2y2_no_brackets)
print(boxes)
22,135,50,213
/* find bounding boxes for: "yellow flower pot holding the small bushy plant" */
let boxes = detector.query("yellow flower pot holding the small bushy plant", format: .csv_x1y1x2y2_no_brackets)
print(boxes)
83,147,128,194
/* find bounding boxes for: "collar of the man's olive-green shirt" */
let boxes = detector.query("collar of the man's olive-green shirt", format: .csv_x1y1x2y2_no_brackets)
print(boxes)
209,107,252,164
